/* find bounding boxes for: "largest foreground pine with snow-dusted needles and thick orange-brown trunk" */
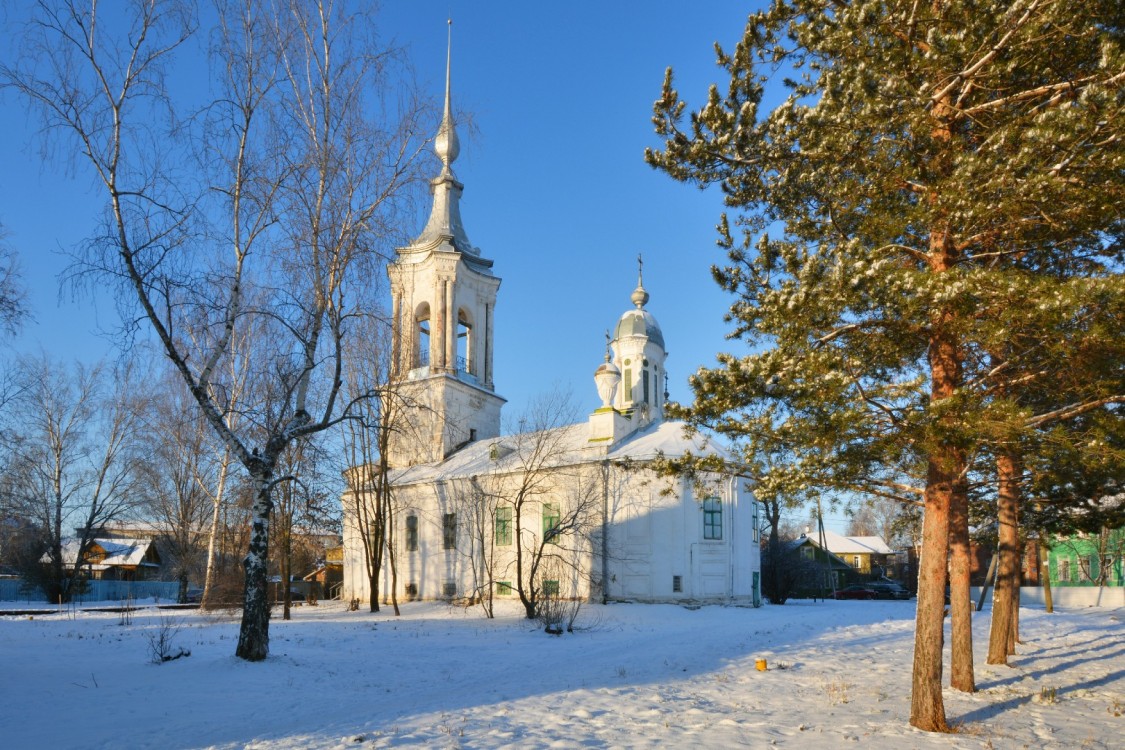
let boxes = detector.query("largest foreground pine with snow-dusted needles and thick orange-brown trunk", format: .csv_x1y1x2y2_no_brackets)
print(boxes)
646,0,1125,731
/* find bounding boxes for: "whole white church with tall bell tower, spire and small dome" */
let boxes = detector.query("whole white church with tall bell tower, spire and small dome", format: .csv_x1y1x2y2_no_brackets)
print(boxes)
342,33,761,605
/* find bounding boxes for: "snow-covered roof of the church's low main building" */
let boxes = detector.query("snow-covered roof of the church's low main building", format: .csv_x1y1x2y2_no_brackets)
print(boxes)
392,421,728,486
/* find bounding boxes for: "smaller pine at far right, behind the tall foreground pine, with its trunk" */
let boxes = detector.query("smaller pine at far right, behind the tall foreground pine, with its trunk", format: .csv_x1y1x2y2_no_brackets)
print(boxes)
969,270,1125,663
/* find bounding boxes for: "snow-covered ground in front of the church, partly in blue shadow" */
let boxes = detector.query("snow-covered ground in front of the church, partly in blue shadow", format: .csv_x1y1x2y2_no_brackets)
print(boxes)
0,602,1125,750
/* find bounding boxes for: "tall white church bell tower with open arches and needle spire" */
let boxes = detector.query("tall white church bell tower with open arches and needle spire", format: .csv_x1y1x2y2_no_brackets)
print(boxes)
384,21,505,468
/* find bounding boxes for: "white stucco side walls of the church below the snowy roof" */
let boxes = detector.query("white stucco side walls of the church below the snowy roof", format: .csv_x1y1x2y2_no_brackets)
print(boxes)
343,462,761,603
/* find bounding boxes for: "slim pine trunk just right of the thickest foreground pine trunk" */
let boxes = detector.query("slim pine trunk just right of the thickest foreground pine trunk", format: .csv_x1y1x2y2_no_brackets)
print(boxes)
950,465,977,693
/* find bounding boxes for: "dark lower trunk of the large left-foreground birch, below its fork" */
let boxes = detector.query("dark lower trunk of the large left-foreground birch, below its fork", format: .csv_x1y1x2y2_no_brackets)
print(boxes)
234,473,273,661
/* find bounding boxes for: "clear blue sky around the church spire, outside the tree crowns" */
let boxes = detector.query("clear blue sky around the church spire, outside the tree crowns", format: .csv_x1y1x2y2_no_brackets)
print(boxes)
0,0,846,528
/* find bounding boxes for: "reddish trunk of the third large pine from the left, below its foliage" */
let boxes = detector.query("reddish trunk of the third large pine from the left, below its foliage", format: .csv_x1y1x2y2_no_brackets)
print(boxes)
988,452,1019,665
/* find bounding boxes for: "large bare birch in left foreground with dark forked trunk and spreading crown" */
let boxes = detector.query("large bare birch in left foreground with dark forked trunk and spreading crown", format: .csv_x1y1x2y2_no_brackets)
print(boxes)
0,0,428,661
